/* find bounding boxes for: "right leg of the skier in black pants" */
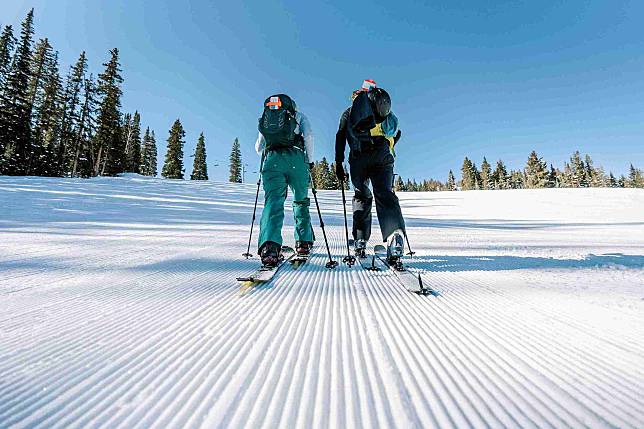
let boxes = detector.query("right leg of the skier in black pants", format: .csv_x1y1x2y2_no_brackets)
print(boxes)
369,146,405,241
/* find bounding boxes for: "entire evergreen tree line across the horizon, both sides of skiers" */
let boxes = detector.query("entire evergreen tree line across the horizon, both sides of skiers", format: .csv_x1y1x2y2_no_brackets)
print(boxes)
0,9,644,191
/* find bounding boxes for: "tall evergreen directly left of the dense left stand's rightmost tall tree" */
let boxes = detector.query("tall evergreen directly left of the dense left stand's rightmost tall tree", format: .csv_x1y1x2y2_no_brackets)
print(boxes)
56,51,88,176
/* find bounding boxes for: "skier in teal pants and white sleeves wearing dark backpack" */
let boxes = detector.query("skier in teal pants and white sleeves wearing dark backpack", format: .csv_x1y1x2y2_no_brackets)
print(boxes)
255,94,313,266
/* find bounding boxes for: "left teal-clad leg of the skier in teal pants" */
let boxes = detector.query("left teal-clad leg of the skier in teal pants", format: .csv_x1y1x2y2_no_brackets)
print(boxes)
258,152,287,249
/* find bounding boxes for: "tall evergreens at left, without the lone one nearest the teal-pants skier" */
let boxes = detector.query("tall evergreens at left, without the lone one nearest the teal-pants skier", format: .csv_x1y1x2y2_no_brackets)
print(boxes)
0,9,208,180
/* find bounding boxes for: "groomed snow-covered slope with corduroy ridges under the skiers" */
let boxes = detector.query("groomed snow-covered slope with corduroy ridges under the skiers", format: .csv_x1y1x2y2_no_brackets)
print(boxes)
0,177,644,428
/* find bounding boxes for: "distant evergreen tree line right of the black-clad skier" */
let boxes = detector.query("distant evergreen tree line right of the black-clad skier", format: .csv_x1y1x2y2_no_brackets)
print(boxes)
394,151,644,192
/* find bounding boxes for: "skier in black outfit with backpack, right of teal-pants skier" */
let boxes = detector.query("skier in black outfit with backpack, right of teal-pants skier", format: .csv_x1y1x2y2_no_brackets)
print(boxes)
335,81,405,261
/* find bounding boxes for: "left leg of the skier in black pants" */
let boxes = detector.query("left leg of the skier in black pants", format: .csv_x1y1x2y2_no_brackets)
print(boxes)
349,154,373,241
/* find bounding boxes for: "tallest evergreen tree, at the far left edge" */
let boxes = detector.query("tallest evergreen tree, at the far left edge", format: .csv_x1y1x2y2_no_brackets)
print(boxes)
0,9,34,175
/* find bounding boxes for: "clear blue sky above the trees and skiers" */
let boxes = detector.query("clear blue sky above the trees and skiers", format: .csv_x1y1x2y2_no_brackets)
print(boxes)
0,0,644,180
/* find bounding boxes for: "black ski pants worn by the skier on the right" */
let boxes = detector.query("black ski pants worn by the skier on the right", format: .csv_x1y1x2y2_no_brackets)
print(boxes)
349,144,405,241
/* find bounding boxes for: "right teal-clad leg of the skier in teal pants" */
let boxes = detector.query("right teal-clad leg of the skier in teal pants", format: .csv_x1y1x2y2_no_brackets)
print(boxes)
284,149,313,242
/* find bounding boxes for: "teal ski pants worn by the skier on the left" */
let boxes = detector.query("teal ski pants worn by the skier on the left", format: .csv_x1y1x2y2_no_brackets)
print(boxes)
259,148,313,249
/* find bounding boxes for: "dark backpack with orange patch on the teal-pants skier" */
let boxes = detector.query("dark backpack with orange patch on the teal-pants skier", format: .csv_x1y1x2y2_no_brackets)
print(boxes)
257,94,303,150
